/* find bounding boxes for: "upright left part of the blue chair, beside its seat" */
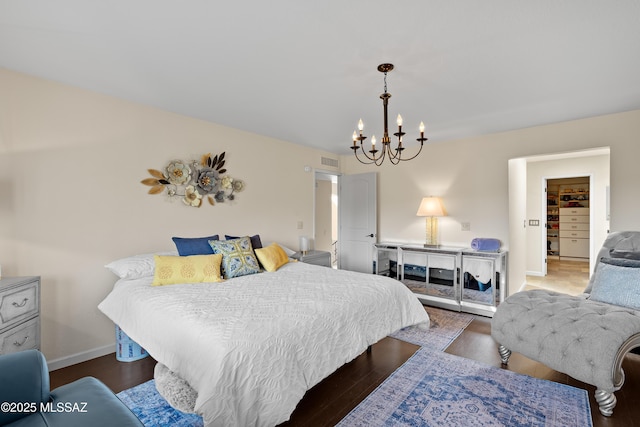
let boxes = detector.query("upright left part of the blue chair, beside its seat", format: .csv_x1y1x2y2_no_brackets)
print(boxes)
0,350,49,425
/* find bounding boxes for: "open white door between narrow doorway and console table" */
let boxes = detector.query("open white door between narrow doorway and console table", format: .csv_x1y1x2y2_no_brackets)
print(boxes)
338,172,378,273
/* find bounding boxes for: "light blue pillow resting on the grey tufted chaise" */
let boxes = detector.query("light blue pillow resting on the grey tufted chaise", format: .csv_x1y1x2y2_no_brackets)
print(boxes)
589,258,640,310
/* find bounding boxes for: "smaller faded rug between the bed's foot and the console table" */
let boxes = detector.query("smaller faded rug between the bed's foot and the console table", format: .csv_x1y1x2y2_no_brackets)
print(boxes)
389,307,473,350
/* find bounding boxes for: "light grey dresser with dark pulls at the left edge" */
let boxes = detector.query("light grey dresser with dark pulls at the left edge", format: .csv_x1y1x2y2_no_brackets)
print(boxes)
0,276,40,354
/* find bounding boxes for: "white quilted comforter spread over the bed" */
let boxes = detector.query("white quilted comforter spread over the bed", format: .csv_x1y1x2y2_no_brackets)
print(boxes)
98,263,429,426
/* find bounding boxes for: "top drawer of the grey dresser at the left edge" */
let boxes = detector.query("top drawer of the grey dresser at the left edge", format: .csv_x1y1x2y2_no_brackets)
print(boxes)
0,280,40,331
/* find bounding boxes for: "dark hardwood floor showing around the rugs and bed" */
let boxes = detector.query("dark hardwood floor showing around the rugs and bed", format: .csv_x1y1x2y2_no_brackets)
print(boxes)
51,316,640,427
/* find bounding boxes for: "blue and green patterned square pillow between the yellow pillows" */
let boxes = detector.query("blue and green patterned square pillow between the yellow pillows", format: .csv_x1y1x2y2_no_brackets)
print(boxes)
209,237,260,279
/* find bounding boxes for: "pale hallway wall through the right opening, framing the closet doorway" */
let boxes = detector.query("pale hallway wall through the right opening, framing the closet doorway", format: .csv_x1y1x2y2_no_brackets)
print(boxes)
526,150,609,275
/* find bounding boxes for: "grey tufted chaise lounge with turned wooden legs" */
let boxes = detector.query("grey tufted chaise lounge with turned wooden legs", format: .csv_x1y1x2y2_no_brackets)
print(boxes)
491,231,640,416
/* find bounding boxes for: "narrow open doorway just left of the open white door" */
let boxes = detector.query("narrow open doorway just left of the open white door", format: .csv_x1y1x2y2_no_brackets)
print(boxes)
313,171,339,268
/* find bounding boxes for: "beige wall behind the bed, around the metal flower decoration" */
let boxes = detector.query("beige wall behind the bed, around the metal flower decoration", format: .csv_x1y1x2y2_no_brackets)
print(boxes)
0,69,337,361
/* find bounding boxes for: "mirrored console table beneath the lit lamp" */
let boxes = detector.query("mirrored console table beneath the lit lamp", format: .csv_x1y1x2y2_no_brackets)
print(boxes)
374,243,507,317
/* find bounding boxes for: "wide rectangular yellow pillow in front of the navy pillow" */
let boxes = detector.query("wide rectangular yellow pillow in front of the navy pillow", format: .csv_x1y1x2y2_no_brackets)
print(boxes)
151,254,222,286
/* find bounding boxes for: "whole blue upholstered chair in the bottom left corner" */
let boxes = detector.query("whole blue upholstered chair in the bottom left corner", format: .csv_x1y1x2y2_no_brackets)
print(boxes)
0,350,143,427
